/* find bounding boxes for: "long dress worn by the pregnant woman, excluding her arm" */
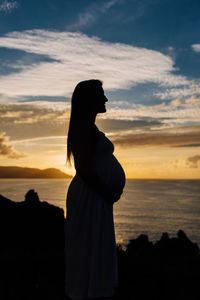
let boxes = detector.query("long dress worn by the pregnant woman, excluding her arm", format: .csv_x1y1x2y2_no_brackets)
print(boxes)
65,131,125,299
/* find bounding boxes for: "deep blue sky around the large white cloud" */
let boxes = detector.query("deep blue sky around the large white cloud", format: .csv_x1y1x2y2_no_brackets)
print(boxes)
0,0,200,104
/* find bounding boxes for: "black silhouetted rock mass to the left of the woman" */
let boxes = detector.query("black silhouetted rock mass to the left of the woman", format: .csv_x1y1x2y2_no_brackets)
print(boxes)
0,190,65,300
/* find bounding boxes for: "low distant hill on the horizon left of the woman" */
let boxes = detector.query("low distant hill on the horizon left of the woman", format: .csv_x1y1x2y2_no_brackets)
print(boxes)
0,166,72,178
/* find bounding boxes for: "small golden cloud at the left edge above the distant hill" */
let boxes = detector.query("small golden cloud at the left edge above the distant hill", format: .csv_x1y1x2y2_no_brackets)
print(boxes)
0,132,26,159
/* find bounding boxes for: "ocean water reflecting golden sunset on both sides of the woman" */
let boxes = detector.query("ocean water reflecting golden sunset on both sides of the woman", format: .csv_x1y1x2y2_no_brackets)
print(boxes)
0,179,200,246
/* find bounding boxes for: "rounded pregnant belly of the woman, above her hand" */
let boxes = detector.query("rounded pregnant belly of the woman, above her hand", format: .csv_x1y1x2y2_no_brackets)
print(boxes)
94,155,126,191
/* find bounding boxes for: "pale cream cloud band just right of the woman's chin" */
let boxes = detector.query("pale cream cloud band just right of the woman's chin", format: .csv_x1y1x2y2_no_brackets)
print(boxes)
103,97,200,127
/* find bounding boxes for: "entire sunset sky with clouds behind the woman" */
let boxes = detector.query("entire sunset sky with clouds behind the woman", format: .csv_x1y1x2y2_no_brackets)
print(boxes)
0,0,200,179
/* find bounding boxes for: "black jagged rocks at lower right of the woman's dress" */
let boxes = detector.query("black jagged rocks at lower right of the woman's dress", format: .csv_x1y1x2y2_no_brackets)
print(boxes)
118,230,200,300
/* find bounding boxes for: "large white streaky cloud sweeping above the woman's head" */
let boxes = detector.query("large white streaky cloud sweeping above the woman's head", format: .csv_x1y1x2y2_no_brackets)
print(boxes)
0,30,190,97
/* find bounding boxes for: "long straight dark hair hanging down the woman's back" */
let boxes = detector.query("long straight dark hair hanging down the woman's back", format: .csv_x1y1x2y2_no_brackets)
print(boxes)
67,79,102,165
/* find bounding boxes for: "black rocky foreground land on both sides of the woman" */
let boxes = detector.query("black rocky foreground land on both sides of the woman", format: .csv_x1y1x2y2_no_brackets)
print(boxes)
0,193,200,300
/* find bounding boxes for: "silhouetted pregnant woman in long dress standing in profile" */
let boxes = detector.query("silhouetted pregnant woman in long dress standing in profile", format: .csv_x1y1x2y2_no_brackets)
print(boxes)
65,79,125,299
